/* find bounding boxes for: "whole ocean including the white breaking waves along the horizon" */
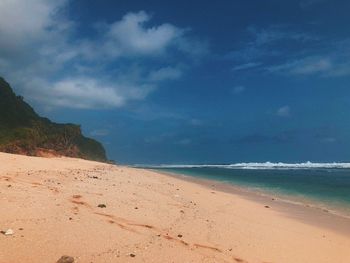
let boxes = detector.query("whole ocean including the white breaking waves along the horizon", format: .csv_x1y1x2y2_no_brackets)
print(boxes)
143,162,350,217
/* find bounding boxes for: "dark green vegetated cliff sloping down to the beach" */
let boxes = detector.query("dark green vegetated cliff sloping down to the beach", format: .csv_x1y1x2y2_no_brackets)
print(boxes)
0,77,107,161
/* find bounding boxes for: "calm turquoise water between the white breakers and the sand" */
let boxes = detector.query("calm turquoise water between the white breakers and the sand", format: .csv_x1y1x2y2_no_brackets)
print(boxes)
153,166,350,215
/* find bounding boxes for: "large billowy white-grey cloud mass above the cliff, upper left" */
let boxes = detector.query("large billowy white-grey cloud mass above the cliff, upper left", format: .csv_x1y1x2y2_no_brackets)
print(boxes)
0,0,205,109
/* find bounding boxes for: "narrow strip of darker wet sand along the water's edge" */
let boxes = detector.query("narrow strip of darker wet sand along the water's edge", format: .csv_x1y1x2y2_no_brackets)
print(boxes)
151,168,350,236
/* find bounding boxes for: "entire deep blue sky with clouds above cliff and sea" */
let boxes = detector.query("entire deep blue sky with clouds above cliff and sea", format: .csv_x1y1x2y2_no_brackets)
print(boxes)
0,0,350,164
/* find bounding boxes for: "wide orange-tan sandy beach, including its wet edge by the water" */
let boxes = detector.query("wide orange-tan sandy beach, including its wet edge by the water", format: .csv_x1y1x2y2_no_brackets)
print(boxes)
0,153,350,263
